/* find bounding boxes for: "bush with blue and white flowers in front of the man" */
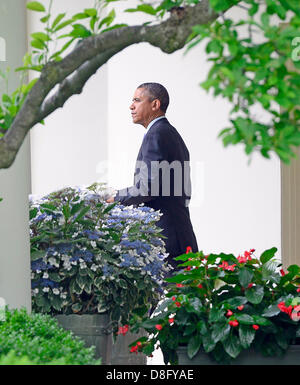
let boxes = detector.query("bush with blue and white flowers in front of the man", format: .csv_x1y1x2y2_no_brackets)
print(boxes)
30,184,169,323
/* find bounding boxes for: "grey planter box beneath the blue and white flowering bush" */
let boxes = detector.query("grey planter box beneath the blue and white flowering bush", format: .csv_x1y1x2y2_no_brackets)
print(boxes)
54,314,147,365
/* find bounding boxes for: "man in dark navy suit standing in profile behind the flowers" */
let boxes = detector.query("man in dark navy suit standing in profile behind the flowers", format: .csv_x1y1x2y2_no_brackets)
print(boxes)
107,83,198,268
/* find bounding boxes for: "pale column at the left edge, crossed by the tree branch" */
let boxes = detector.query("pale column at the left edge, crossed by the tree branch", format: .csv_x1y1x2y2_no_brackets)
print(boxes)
0,0,31,311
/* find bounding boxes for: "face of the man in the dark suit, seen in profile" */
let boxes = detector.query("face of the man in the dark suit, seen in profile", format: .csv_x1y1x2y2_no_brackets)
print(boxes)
129,88,157,127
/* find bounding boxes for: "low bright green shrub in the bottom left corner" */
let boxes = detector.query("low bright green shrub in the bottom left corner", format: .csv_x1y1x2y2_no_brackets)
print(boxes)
0,309,100,365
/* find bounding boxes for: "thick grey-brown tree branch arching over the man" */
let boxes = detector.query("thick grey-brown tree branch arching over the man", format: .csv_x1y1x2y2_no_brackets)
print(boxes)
0,0,218,168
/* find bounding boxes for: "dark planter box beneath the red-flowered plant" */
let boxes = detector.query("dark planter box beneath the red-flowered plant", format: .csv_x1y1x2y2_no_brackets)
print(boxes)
177,345,300,365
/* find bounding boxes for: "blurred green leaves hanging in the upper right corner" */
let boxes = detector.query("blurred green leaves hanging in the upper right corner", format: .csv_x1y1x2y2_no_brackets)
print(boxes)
188,0,300,163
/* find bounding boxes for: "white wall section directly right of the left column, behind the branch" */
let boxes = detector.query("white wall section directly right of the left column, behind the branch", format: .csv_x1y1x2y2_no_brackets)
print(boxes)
27,0,107,194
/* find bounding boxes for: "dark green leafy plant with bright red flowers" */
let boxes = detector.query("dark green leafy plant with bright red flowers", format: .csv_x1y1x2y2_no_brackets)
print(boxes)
122,248,300,364
